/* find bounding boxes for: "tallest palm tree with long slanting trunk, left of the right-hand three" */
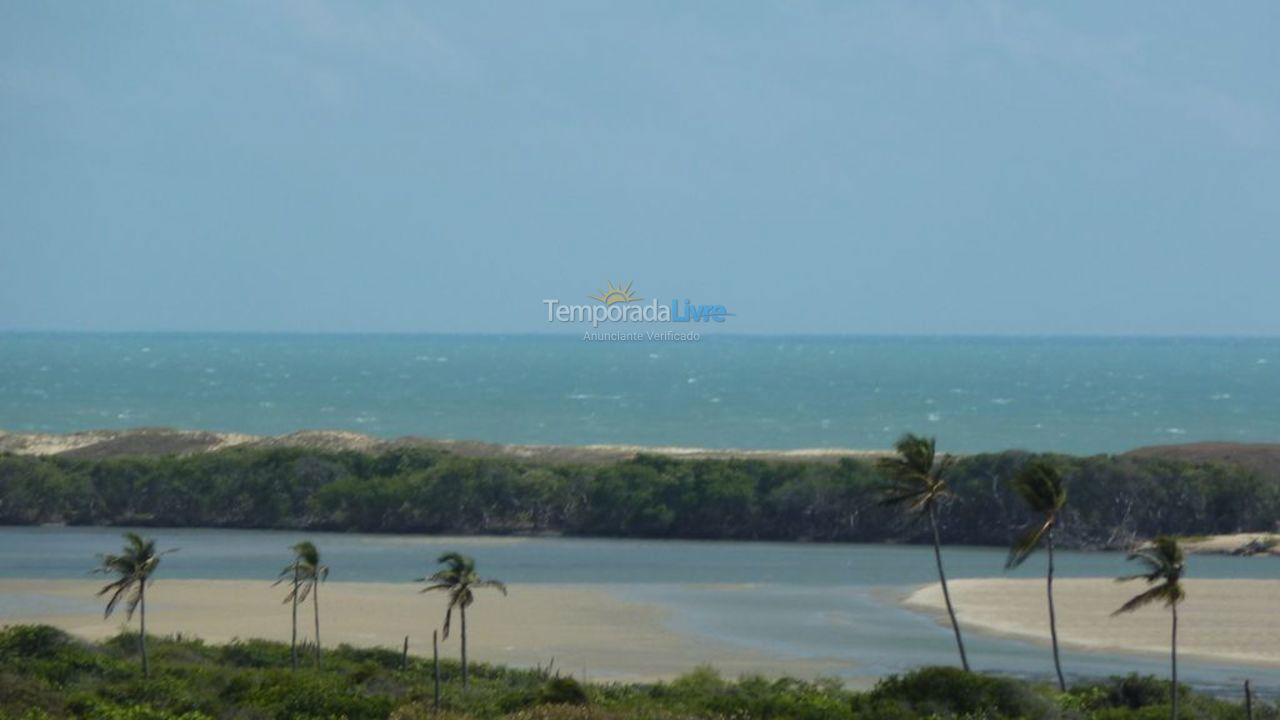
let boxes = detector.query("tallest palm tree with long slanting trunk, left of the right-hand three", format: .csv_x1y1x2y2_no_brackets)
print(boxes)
879,433,969,670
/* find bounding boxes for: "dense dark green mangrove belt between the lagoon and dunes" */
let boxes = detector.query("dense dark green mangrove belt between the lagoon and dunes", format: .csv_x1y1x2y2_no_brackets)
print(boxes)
0,447,1280,548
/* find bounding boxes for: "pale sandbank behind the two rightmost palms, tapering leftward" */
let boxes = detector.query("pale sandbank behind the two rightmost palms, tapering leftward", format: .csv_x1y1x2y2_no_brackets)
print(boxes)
904,578,1280,667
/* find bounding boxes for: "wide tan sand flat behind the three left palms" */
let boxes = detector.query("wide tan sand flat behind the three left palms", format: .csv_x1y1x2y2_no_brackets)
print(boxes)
0,579,849,682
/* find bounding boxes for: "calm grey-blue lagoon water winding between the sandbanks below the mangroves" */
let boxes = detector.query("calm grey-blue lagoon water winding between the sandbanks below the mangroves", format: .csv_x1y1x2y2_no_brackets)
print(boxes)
0,528,1280,694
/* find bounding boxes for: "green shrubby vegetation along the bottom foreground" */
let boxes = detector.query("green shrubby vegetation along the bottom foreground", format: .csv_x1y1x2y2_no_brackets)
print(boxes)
0,625,1280,720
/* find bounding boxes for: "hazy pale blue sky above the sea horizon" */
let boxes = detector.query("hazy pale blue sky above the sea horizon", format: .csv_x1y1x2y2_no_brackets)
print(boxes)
0,0,1280,334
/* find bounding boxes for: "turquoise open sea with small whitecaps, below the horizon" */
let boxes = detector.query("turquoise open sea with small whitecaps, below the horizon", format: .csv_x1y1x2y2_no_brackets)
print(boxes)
0,333,1280,454
